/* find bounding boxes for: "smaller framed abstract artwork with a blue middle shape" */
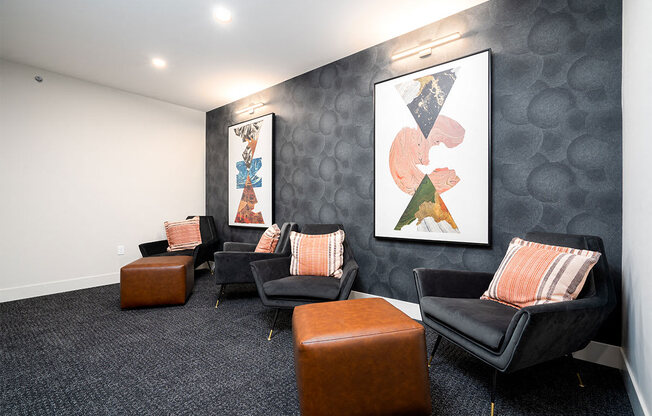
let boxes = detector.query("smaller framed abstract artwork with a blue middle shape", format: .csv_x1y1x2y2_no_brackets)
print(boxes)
228,113,274,228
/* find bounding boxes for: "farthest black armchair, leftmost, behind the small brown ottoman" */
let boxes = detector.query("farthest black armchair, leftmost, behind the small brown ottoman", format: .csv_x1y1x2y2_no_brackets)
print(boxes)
138,215,218,268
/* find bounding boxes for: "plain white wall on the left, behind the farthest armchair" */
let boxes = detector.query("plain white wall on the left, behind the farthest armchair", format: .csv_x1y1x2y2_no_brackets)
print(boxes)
0,60,206,301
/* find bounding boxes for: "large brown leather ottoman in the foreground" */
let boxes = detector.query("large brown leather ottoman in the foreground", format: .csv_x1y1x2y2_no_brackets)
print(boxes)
292,298,431,416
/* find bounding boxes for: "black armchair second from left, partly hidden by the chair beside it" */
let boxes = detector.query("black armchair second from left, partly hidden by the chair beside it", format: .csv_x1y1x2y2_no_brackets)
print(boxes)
214,222,299,308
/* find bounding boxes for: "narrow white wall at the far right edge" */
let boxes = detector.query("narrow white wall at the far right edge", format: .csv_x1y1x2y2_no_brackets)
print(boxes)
622,0,652,414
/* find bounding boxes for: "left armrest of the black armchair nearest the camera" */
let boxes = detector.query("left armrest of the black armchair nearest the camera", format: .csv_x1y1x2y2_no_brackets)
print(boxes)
414,268,493,299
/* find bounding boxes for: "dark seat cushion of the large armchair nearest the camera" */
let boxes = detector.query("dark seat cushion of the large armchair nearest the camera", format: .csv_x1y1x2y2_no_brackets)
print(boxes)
421,296,518,351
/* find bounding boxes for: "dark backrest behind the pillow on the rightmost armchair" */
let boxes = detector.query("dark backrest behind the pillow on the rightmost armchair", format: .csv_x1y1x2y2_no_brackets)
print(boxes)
525,232,616,306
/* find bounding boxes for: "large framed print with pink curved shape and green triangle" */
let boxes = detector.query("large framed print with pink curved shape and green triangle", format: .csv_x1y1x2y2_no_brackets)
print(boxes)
374,50,491,245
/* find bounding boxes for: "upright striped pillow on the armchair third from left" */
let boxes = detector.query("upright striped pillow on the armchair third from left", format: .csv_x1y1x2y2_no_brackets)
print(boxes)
290,230,344,279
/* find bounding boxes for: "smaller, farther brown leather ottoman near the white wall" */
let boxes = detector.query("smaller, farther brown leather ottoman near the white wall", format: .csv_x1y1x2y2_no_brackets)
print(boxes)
120,256,195,309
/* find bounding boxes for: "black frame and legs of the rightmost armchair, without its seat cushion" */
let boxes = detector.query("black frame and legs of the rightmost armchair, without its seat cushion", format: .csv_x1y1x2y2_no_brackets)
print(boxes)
414,232,616,414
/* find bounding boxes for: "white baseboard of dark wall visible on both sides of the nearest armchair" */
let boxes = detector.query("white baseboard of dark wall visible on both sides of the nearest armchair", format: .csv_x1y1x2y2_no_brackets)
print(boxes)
349,290,624,370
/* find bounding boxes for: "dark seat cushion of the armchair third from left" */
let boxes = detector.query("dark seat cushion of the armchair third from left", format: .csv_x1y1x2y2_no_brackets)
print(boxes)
263,276,340,300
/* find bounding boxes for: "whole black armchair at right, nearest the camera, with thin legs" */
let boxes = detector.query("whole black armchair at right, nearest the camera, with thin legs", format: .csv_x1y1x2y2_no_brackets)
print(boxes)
414,232,616,415
